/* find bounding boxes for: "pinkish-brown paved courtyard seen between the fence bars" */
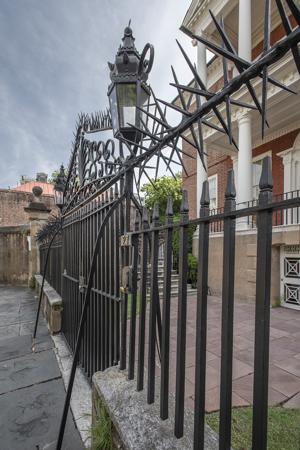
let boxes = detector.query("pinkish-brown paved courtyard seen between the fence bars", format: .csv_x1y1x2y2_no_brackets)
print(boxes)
165,296,300,412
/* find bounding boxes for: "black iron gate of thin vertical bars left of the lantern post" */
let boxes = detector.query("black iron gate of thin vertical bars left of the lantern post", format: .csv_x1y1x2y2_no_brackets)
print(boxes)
62,185,124,379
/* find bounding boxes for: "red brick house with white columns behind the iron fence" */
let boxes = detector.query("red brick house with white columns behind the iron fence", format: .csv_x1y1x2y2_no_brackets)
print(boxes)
183,0,300,310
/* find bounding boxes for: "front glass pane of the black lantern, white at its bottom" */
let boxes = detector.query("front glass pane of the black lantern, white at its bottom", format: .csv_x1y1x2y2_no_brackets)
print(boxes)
118,83,136,128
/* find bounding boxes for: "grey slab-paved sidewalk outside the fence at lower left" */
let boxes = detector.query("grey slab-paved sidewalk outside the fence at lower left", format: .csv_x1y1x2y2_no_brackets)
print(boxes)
0,285,84,450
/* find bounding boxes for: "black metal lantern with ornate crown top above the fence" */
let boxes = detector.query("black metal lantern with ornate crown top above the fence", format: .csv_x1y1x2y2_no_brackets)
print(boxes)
107,26,154,143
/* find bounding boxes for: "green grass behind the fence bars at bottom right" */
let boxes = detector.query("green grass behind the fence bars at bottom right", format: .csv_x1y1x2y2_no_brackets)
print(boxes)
206,406,300,450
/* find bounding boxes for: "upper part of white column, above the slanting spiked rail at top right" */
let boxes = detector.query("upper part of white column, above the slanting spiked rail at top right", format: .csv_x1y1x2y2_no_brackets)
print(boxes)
239,0,252,61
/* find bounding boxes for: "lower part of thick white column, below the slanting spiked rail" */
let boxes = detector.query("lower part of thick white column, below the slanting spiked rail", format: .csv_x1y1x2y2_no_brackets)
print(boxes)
237,114,253,203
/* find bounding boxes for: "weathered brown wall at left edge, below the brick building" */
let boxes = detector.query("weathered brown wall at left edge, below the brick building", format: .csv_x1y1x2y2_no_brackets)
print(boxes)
0,225,30,285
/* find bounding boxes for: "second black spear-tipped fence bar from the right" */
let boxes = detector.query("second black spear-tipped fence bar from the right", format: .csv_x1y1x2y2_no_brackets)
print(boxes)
219,170,236,450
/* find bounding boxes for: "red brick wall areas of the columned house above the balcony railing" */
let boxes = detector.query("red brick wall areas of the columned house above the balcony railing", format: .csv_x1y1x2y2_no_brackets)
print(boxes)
183,128,300,218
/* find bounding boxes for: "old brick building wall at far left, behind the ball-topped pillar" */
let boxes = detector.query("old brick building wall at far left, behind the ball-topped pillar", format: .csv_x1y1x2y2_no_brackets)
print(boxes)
0,189,57,227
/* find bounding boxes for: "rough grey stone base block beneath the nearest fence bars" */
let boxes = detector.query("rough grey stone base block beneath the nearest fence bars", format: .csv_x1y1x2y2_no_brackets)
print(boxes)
92,367,219,450
